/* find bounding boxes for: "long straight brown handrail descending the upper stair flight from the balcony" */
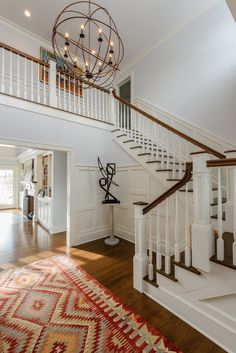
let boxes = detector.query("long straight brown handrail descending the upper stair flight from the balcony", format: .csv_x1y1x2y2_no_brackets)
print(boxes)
112,90,226,159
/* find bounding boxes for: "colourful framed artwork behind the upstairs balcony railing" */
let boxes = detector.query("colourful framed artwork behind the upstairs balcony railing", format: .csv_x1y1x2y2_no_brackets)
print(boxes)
40,47,83,97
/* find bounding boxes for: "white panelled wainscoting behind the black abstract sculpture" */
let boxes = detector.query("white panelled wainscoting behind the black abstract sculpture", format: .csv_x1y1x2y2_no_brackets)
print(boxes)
76,165,185,248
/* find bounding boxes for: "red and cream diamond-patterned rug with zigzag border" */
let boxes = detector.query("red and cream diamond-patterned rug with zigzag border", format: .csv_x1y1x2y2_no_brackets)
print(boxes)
0,256,181,353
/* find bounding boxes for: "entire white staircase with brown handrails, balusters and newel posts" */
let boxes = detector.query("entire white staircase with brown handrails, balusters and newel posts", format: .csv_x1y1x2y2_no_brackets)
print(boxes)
109,92,236,353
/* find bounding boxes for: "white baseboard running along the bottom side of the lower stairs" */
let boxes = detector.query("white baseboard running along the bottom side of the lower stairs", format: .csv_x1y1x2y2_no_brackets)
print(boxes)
144,282,235,353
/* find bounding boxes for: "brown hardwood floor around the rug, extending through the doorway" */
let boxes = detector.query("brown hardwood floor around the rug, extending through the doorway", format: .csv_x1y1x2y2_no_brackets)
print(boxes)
0,210,225,353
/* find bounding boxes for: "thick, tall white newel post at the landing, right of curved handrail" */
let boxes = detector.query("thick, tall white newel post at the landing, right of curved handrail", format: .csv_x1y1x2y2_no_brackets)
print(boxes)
192,153,214,272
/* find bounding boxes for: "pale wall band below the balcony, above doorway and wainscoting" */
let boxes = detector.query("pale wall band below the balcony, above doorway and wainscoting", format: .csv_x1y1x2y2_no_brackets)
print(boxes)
0,105,134,165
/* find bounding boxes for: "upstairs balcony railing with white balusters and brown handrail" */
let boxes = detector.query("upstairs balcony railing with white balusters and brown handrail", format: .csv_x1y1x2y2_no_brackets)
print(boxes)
0,43,112,123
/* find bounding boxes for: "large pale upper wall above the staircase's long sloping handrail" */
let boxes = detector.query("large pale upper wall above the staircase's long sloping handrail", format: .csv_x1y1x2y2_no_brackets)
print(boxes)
120,0,236,144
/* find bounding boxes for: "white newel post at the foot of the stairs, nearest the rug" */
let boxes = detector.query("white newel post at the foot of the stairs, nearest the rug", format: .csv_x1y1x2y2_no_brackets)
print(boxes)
133,202,148,293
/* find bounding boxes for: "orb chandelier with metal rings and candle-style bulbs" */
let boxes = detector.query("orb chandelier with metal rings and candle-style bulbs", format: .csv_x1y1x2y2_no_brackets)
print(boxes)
52,0,124,88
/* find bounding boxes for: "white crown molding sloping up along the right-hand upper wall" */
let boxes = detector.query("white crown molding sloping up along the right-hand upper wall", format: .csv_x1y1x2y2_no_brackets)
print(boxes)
117,0,220,75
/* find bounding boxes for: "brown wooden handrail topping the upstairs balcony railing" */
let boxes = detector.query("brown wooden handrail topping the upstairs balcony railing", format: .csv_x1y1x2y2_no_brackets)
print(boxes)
0,42,110,94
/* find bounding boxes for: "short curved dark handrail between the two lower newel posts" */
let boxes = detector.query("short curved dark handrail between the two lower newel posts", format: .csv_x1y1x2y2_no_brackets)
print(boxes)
143,162,193,214
